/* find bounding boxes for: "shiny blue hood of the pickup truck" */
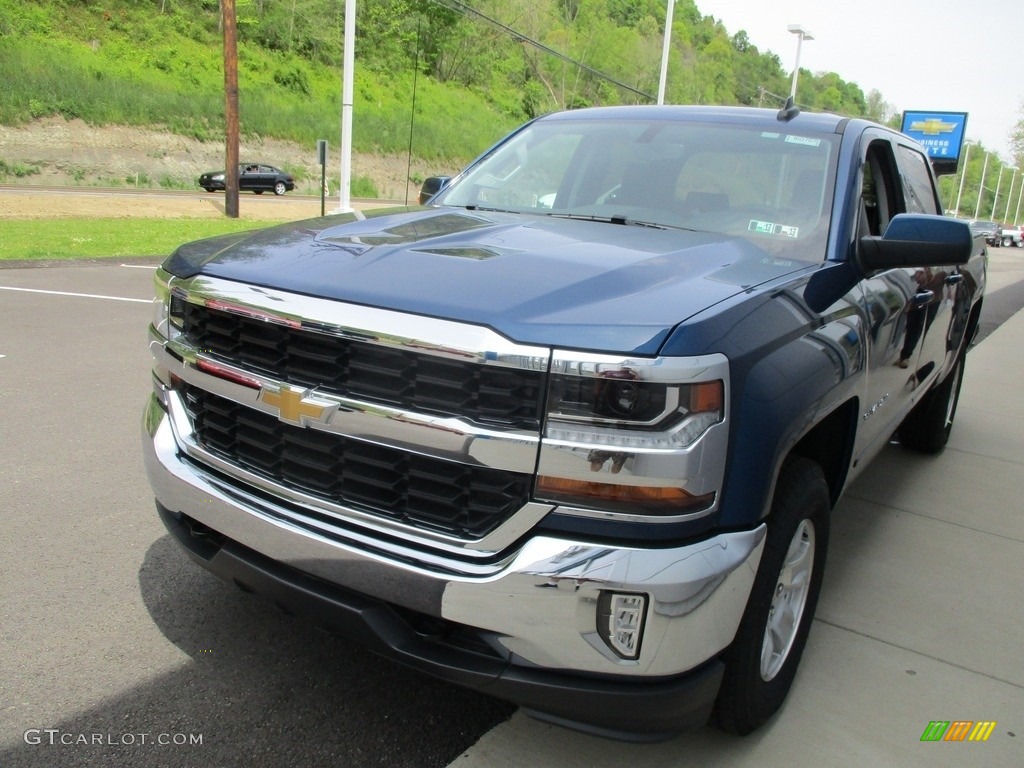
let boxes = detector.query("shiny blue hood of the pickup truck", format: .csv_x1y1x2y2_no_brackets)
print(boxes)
165,208,808,354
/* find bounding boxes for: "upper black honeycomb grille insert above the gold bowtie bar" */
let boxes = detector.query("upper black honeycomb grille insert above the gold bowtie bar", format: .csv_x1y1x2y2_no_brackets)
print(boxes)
184,302,544,431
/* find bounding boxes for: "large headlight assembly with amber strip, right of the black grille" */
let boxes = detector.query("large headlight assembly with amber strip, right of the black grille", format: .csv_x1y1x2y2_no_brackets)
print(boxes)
536,350,728,520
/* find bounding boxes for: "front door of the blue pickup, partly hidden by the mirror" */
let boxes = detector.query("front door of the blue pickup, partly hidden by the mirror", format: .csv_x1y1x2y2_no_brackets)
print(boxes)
854,137,930,460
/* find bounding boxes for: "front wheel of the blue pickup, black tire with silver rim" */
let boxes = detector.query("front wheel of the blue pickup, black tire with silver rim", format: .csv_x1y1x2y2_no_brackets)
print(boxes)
712,456,830,735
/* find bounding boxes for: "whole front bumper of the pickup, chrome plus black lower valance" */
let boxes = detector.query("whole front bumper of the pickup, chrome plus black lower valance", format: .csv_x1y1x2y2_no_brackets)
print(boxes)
143,396,765,738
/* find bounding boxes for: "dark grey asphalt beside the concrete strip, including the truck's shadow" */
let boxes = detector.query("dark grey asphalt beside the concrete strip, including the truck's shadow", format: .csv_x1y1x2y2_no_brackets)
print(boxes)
0,249,1024,767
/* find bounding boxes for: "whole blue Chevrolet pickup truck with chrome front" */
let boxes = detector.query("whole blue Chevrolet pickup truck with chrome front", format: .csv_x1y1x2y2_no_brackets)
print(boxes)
143,106,986,739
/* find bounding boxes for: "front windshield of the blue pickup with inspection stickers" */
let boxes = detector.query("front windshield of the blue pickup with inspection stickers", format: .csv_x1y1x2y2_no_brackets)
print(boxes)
435,119,838,260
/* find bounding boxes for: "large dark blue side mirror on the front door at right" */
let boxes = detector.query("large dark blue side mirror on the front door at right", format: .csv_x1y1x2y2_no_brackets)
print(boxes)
857,213,974,274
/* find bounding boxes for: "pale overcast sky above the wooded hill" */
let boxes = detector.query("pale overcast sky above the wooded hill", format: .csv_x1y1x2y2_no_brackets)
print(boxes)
696,0,1024,163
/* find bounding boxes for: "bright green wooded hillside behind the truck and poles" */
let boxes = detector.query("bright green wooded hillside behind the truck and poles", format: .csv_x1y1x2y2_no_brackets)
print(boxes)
0,0,905,198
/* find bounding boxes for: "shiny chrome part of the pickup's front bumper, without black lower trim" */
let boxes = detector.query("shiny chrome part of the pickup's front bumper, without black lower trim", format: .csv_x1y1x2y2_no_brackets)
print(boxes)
143,396,765,682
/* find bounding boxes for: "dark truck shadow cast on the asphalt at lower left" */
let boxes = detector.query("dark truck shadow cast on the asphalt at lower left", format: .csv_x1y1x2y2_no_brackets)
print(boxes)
0,536,515,767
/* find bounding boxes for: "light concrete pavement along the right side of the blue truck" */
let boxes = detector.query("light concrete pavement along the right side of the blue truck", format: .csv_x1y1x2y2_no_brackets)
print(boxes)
452,305,1024,768
